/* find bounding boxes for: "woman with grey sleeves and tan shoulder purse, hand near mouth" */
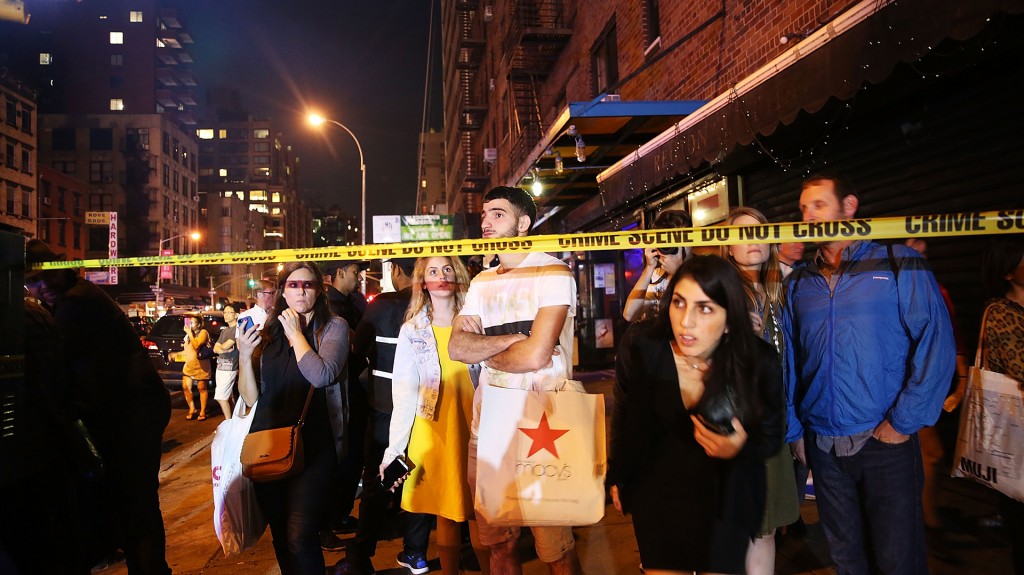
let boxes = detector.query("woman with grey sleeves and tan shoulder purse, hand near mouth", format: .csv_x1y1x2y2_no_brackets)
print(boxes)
238,262,348,575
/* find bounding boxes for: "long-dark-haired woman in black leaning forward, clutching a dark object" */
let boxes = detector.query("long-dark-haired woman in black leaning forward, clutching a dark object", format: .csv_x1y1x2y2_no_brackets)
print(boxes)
608,256,782,575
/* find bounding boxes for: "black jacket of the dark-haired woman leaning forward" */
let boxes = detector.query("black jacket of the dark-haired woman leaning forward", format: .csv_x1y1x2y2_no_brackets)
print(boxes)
607,322,784,535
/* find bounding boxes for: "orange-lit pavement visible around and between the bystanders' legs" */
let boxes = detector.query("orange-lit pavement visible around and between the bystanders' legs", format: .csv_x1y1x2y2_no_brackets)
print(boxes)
93,370,1012,575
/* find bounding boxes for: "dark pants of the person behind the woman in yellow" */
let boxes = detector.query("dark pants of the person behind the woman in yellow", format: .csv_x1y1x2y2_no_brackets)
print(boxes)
347,409,433,562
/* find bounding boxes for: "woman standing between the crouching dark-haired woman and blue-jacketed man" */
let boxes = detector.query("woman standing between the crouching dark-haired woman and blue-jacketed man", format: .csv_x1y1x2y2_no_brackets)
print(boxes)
722,207,800,575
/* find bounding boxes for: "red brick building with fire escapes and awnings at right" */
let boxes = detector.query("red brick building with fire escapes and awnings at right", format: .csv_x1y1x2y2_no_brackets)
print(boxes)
442,0,1024,363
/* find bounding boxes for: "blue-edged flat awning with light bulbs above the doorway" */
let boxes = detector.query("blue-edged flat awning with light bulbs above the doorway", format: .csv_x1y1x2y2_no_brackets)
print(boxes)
507,96,706,229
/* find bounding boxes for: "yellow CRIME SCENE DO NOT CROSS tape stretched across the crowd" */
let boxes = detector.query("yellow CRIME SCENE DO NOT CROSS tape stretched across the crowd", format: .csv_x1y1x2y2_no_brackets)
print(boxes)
34,210,1024,269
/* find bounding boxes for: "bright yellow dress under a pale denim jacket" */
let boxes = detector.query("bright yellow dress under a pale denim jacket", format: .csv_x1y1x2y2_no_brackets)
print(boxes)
401,326,473,522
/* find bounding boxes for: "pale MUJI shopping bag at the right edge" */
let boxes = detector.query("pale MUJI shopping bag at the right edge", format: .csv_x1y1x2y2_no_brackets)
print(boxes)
952,366,1024,501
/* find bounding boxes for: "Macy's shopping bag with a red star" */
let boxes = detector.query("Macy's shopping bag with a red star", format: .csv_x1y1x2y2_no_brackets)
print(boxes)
474,380,607,526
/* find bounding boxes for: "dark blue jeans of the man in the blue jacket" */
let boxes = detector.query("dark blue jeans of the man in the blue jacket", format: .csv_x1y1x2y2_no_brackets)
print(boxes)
805,431,928,575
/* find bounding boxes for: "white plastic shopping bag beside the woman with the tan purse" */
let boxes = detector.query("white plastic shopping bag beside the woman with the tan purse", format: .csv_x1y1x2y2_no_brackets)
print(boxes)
210,399,266,557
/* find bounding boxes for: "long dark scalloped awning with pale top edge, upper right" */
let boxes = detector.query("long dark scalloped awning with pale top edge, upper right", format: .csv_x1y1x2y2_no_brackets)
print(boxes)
598,0,1024,215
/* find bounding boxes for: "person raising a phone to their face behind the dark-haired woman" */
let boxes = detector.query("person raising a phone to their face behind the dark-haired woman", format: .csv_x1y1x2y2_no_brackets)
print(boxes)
623,210,693,321
